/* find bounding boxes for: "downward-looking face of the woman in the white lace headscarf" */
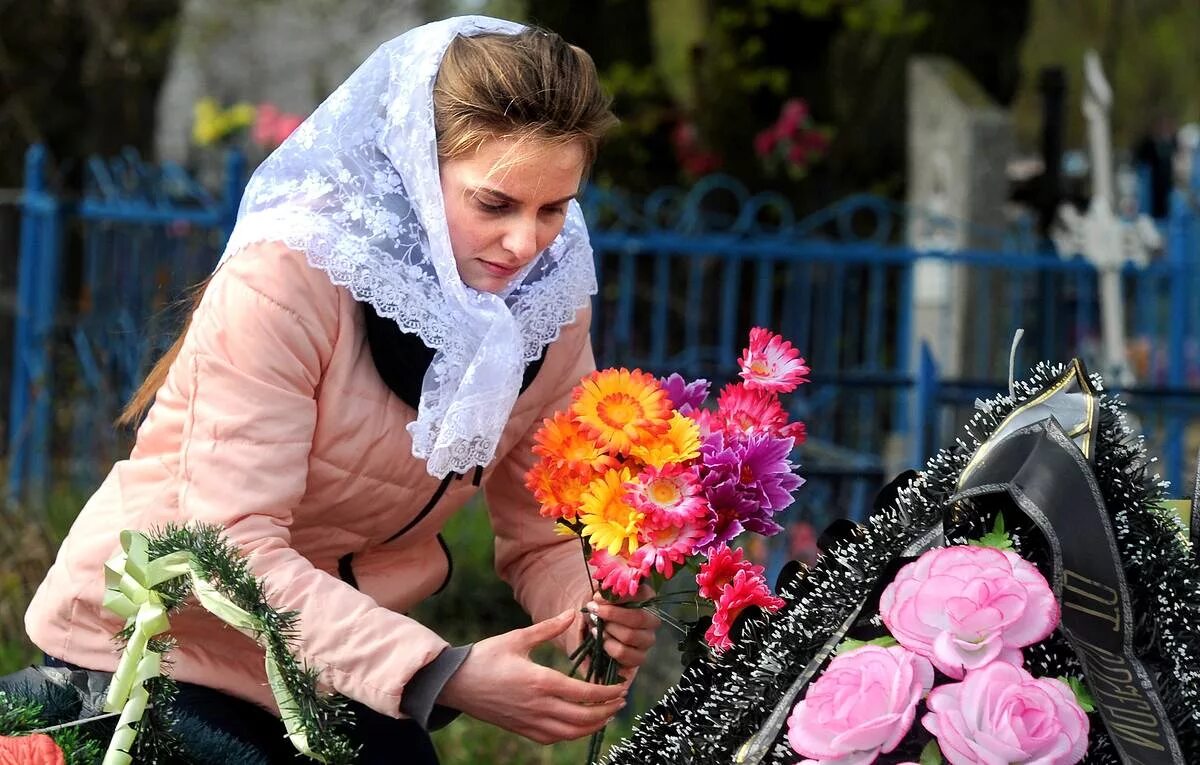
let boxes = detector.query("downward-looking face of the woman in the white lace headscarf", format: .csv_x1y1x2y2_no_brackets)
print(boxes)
442,138,583,293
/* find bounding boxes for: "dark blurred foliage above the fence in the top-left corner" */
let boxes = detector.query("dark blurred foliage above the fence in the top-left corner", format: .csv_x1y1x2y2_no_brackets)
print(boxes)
0,0,180,187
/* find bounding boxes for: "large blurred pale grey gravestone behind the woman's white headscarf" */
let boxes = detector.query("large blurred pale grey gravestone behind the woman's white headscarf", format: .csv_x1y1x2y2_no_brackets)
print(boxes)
155,0,427,162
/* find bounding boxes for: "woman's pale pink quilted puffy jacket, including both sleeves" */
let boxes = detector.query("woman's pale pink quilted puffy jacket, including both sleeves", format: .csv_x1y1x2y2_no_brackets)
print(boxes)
25,243,594,717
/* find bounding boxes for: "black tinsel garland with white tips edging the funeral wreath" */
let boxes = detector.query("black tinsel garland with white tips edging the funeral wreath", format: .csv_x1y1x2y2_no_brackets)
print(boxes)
605,363,1200,765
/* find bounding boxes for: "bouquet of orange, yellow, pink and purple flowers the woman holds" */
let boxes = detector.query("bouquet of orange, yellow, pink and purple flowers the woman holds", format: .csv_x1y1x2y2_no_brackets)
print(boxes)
526,327,809,714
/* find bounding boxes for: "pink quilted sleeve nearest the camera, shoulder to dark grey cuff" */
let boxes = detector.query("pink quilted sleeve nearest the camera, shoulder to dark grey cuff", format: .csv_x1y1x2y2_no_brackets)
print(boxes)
172,243,448,717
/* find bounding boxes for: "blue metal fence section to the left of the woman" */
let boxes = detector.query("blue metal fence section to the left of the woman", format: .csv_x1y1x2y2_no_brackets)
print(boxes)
6,146,245,506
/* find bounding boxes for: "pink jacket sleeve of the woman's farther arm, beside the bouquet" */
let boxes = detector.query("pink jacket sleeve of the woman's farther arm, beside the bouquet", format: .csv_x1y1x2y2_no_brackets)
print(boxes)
485,308,595,651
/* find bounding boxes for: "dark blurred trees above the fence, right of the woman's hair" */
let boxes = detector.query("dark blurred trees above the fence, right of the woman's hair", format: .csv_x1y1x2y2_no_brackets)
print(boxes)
506,0,1031,209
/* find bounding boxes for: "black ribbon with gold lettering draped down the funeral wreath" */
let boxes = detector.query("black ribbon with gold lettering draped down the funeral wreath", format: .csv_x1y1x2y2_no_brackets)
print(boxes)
950,417,1183,765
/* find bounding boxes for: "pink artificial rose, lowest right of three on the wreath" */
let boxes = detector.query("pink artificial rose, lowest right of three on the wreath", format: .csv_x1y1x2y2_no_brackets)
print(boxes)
920,662,1088,765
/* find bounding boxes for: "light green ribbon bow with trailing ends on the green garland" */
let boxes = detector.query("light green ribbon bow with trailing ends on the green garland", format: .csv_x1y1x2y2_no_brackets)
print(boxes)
102,531,325,765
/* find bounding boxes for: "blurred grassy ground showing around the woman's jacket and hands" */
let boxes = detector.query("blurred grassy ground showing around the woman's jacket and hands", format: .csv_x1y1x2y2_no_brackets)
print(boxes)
0,482,648,765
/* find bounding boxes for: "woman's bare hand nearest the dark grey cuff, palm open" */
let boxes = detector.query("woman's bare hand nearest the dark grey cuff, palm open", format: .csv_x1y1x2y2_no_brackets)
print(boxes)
438,609,629,743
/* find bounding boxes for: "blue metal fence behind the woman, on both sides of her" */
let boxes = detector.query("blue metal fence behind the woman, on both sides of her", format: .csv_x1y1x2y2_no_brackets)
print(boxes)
8,149,1200,537
